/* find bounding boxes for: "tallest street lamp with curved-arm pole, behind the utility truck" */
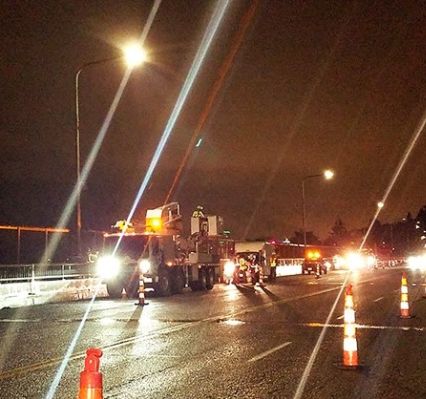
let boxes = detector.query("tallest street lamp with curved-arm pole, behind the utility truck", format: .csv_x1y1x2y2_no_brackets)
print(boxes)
75,43,147,255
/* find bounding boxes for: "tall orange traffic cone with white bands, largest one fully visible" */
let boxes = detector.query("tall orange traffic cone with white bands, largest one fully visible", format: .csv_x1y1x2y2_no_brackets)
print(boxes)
343,284,359,369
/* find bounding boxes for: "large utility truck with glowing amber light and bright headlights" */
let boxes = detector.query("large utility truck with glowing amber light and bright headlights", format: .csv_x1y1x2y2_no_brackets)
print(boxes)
98,202,234,297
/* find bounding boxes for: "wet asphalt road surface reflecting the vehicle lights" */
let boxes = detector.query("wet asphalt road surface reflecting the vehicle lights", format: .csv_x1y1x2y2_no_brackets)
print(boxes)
0,269,426,399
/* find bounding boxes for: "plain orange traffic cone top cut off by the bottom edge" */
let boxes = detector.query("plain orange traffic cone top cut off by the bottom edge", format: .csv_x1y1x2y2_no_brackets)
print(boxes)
78,348,103,399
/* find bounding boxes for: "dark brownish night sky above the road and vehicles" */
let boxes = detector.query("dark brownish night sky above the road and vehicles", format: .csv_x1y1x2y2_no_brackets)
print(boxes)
0,0,426,238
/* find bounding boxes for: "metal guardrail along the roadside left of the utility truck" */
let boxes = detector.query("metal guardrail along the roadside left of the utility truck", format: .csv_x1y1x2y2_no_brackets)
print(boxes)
0,263,95,284
